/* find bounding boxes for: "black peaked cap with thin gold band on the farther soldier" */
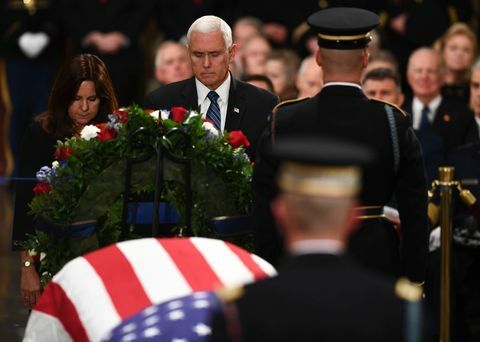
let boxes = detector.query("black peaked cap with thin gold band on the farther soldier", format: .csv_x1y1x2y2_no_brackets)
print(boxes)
308,7,380,50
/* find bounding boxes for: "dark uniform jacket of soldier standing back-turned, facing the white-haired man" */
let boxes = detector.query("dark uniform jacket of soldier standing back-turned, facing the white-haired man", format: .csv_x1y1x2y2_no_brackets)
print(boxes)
253,86,428,281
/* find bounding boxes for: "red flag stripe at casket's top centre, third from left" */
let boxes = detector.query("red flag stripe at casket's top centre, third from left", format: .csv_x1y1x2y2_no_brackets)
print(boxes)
157,238,223,291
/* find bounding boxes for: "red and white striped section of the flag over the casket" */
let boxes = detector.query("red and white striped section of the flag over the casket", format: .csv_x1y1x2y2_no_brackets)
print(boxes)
24,237,276,342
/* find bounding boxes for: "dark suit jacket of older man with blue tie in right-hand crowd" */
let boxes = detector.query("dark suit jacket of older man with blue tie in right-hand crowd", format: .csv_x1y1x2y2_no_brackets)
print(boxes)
403,97,478,151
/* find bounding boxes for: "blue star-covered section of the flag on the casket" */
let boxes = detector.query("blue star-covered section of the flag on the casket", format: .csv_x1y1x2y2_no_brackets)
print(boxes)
106,292,222,342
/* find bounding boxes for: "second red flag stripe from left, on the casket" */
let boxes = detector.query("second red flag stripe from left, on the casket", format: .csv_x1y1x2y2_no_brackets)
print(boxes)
84,245,152,319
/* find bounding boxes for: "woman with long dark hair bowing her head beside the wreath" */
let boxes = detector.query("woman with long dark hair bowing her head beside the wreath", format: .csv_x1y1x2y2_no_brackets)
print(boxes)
12,54,117,308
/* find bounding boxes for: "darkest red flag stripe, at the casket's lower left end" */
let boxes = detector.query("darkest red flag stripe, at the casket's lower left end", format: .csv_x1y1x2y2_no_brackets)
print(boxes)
34,281,88,341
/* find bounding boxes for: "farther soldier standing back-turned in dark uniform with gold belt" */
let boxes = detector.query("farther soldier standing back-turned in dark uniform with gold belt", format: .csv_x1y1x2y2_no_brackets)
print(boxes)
253,8,428,284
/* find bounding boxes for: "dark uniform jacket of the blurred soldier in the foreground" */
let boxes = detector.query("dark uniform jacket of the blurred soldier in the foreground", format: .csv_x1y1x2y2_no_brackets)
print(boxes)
212,254,414,342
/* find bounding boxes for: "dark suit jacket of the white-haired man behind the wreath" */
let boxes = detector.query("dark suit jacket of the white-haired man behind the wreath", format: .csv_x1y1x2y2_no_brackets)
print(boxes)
143,77,278,160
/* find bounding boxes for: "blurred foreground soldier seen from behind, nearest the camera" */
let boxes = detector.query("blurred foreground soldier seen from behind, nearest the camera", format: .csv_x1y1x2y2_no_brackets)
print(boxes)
211,136,422,342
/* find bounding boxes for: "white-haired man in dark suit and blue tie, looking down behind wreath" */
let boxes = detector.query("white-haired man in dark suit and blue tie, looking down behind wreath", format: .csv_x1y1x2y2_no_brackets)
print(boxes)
143,16,278,157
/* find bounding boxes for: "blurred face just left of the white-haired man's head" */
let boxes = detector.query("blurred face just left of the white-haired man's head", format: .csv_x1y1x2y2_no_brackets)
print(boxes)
155,43,192,84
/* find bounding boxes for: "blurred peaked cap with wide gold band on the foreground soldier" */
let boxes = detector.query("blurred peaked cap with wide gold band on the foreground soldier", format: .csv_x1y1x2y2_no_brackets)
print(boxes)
270,137,374,197
